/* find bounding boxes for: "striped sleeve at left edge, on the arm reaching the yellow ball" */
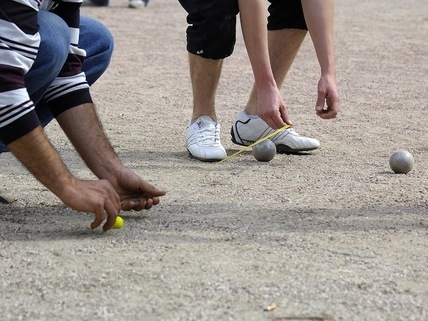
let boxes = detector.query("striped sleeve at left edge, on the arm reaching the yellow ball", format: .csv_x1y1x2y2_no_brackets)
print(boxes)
0,0,40,144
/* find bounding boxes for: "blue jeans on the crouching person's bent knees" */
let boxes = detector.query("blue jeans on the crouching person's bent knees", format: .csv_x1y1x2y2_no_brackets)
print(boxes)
0,11,114,153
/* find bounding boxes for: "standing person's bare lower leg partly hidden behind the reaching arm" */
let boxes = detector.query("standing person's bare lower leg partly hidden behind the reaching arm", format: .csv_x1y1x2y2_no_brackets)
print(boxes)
245,29,307,115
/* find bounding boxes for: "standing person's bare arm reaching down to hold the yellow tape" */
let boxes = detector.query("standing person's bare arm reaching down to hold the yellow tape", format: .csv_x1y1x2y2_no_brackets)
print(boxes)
238,0,291,129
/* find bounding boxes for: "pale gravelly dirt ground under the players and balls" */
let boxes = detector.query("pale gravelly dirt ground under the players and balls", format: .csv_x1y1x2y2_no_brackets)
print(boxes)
0,0,428,321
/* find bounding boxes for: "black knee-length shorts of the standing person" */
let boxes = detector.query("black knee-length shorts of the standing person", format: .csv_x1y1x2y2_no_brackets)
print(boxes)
179,0,307,59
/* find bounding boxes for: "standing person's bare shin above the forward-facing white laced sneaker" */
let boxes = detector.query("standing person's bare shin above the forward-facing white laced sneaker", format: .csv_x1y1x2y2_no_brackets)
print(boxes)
189,53,223,122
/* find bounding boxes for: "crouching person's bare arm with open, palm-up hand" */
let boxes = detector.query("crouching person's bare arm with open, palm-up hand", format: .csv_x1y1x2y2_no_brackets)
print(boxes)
57,103,165,211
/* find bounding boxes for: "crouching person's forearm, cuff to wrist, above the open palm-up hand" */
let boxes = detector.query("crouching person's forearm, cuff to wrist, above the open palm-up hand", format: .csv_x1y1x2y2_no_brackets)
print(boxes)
57,104,122,180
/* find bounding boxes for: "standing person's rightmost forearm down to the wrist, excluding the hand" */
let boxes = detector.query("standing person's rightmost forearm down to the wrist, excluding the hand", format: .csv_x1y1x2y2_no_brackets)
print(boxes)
302,0,336,75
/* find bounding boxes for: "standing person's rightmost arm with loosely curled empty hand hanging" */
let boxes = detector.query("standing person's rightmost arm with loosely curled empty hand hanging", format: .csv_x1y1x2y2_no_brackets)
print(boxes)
302,0,339,119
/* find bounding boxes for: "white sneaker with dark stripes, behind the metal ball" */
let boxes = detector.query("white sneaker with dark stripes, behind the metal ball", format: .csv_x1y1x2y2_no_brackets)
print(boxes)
230,111,320,154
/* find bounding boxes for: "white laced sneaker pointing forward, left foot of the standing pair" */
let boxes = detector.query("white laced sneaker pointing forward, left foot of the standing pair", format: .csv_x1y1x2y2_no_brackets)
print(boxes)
186,116,227,162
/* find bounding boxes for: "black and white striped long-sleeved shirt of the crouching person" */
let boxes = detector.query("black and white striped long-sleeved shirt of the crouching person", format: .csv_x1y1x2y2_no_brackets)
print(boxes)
0,0,92,144
